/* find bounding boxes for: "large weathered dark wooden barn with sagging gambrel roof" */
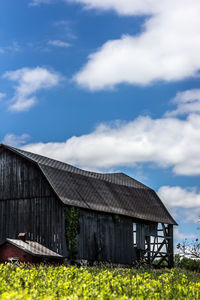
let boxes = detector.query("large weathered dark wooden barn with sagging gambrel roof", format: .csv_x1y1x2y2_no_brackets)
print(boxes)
0,144,177,267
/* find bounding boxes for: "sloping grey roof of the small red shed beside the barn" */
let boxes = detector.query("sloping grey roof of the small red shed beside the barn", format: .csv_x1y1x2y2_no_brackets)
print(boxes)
6,238,63,259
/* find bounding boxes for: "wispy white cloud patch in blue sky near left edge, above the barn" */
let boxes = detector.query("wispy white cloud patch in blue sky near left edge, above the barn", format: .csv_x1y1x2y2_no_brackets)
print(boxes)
3,67,62,112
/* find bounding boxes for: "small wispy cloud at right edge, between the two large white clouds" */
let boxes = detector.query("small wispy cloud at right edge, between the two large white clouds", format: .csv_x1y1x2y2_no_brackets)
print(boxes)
165,89,200,117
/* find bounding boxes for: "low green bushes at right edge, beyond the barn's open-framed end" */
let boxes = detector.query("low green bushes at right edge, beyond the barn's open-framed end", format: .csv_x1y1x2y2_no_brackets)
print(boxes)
174,254,200,273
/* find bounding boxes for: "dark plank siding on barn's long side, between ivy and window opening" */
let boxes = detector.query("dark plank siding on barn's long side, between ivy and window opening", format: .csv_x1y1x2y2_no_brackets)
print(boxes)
77,210,135,264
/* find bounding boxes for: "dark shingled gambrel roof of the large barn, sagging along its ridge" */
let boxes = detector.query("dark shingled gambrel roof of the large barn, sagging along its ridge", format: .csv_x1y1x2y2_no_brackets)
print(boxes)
1,146,177,225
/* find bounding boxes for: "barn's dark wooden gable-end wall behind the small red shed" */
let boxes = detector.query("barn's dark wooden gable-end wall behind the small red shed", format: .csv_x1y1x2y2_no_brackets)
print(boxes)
0,149,66,255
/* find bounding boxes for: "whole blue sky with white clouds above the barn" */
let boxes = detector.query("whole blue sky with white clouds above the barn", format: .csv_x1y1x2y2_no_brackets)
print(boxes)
0,0,200,241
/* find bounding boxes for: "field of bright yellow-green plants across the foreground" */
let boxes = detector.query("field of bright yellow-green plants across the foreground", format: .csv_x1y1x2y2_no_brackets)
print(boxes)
0,265,200,300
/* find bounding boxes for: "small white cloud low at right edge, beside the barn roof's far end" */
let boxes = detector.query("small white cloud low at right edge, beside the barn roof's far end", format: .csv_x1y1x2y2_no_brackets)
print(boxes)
158,186,200,208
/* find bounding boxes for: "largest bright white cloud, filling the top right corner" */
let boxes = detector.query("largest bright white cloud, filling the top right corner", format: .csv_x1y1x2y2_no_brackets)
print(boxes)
70,0,200,90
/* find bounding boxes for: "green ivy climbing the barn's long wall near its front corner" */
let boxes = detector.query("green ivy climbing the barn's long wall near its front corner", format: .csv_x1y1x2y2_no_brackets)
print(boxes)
65,207,80,259
